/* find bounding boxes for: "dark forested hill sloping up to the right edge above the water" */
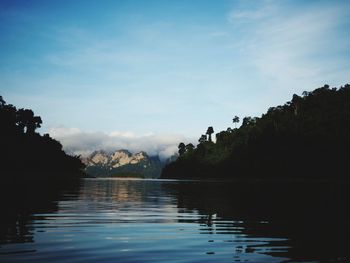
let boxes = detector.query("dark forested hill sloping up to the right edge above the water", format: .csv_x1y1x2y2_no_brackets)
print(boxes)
162,84,350,180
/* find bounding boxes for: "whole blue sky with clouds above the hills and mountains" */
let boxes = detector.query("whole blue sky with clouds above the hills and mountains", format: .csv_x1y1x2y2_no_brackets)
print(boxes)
0,0,350,155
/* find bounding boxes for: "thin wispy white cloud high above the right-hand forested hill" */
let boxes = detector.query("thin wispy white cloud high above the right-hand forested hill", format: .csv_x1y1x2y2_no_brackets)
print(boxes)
227,0,350,92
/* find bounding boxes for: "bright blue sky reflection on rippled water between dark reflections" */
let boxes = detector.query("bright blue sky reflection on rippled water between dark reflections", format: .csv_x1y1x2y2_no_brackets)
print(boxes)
28,180,287,262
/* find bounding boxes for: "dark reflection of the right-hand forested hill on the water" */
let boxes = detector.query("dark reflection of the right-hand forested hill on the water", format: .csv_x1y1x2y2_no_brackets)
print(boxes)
164,182,350,261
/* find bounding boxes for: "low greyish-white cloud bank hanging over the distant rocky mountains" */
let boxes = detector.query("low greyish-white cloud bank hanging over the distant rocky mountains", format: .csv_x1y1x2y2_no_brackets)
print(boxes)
49,127,193,159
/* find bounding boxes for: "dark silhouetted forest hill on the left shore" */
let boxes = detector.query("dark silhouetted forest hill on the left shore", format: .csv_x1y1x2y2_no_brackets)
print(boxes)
0,96,84,182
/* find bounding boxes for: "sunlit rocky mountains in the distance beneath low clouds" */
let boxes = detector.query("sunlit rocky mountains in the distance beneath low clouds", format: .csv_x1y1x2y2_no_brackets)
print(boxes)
82,150,173,178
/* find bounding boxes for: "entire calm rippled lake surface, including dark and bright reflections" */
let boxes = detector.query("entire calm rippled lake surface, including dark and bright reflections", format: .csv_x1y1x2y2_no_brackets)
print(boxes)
0,179,350,262
